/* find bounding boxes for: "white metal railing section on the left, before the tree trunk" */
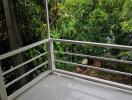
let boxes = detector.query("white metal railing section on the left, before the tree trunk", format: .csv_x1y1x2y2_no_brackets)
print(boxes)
0,39,52,100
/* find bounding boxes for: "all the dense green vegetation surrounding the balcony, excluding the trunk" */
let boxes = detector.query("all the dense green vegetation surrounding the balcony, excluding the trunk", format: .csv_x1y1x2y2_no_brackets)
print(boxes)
0,0,132,94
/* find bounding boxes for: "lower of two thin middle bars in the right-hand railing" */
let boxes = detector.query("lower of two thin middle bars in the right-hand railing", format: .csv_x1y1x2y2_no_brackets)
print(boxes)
55,60,132,76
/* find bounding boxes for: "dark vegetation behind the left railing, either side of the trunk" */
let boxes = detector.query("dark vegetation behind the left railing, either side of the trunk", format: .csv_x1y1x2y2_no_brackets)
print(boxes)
0,0,47,94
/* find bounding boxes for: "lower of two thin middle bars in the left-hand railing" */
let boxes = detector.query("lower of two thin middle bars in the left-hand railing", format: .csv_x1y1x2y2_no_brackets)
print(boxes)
5,61,48,87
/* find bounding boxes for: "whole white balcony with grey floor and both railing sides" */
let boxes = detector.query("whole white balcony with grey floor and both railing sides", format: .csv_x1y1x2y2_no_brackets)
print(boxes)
0,38,132,100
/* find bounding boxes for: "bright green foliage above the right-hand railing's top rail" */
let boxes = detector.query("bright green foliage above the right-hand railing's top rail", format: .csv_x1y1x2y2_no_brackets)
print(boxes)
52,0,132,45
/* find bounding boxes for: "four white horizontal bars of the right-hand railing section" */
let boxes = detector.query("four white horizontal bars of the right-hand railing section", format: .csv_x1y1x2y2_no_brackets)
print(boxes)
52,39,132,91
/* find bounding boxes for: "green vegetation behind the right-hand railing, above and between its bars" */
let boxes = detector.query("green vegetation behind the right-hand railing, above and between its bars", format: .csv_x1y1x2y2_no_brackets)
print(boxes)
50,0,132,84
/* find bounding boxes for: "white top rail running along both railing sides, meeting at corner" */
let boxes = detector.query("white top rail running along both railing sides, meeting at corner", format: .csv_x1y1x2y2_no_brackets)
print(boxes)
0,38,132,60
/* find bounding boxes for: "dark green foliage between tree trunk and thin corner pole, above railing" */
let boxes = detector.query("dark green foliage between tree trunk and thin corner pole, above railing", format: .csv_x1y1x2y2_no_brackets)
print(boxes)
15,0,46,45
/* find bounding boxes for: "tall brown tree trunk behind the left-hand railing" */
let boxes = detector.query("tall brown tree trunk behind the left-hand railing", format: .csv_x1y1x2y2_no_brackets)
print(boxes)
3,0,26,87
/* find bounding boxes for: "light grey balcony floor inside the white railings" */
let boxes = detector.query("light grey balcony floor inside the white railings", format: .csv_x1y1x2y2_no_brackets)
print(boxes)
15,74,132,100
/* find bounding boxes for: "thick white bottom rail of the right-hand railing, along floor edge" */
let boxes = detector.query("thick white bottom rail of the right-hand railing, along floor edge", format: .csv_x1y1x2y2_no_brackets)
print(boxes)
54,69,132,94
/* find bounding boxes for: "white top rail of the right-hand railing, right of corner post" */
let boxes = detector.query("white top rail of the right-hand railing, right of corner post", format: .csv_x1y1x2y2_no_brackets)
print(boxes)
52,39,132,50
